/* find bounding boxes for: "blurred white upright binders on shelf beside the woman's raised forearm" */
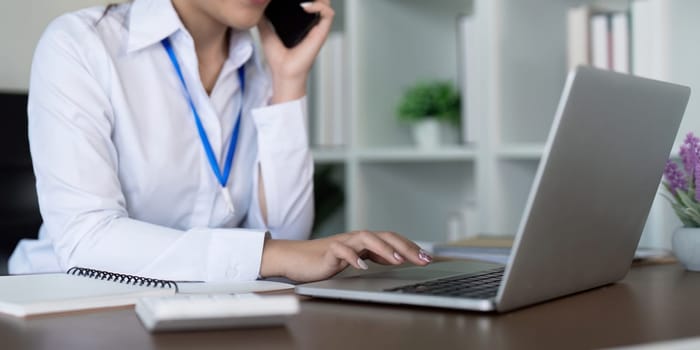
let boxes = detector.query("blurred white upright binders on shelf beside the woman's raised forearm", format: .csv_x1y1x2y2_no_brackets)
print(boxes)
311,32,348,147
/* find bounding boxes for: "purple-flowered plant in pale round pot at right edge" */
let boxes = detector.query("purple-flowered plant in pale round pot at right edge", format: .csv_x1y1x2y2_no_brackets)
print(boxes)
664,133,700,271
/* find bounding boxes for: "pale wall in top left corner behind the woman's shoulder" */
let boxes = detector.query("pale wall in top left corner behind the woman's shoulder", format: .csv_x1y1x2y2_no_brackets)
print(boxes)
0,0,110,90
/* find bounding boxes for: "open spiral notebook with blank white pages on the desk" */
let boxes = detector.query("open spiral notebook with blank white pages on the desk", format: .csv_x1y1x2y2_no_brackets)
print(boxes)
0,267,294,317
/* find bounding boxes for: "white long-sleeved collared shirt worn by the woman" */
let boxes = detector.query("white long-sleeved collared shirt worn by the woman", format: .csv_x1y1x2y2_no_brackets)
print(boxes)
9,0,313,281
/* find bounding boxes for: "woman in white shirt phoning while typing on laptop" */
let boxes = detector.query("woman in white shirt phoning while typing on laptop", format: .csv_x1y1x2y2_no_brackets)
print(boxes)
9,0,431,281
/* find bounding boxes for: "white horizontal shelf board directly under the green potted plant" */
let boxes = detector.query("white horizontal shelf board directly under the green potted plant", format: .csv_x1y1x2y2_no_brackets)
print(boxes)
357,147,476,162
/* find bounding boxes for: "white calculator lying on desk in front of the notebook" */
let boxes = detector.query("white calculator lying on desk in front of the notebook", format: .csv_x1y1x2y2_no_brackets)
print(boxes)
136,293,299,332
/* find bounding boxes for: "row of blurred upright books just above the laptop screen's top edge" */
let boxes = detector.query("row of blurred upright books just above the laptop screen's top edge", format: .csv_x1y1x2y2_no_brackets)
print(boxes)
567,4,631,73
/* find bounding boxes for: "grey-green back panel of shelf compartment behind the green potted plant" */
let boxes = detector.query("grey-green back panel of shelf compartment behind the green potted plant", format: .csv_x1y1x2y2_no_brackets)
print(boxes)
346,0,473,147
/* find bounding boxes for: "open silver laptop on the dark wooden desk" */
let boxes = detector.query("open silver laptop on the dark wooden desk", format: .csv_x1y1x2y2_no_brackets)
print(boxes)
296,67,690,312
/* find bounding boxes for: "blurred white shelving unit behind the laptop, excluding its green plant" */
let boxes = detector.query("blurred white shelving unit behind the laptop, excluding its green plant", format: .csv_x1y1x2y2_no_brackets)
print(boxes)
312,0,700,247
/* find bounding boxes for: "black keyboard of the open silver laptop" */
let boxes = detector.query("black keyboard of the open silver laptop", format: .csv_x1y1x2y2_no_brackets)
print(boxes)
385,267,505,299
